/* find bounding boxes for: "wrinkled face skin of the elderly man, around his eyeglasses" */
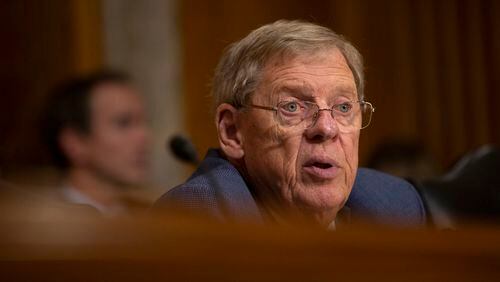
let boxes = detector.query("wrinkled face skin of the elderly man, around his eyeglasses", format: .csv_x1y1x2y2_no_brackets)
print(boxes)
226,49,359,224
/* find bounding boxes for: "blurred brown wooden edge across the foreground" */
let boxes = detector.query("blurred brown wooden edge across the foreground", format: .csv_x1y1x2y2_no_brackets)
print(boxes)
0,208,500,281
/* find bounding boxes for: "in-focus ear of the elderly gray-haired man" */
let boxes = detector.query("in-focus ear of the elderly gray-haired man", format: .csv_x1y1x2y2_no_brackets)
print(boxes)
215,103,245,159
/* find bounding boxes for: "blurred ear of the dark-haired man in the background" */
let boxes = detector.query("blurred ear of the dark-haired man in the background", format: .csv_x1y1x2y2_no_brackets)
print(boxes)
58,128,88,166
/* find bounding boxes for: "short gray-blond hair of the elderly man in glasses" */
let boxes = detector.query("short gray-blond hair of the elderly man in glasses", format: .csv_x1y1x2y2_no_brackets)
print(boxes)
212,20,364,108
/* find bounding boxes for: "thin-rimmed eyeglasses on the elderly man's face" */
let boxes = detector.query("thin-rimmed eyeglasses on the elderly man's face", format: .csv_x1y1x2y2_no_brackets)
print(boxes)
250,100,375,132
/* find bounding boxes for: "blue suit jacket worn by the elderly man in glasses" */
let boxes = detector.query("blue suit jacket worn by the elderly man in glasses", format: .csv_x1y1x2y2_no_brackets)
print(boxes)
153,150,425,226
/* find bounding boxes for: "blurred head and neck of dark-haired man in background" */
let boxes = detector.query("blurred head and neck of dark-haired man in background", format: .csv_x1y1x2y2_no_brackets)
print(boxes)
42,72,149,215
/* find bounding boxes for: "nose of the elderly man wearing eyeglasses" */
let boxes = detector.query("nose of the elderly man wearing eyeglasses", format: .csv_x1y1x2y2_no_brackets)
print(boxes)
305,109,339,142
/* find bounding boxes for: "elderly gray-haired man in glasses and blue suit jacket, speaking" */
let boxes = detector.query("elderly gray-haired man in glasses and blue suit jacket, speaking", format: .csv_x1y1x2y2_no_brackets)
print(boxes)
156,20,425,226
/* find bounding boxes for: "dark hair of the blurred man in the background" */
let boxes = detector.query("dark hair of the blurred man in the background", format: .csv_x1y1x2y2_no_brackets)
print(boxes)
40,71,130,169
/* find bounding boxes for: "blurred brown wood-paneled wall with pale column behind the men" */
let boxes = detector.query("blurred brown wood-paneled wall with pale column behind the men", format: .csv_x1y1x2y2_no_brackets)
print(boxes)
0,0,500,188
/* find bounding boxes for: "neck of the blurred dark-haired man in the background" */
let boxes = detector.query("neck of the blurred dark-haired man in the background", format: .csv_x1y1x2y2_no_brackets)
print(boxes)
66,168,121,207
